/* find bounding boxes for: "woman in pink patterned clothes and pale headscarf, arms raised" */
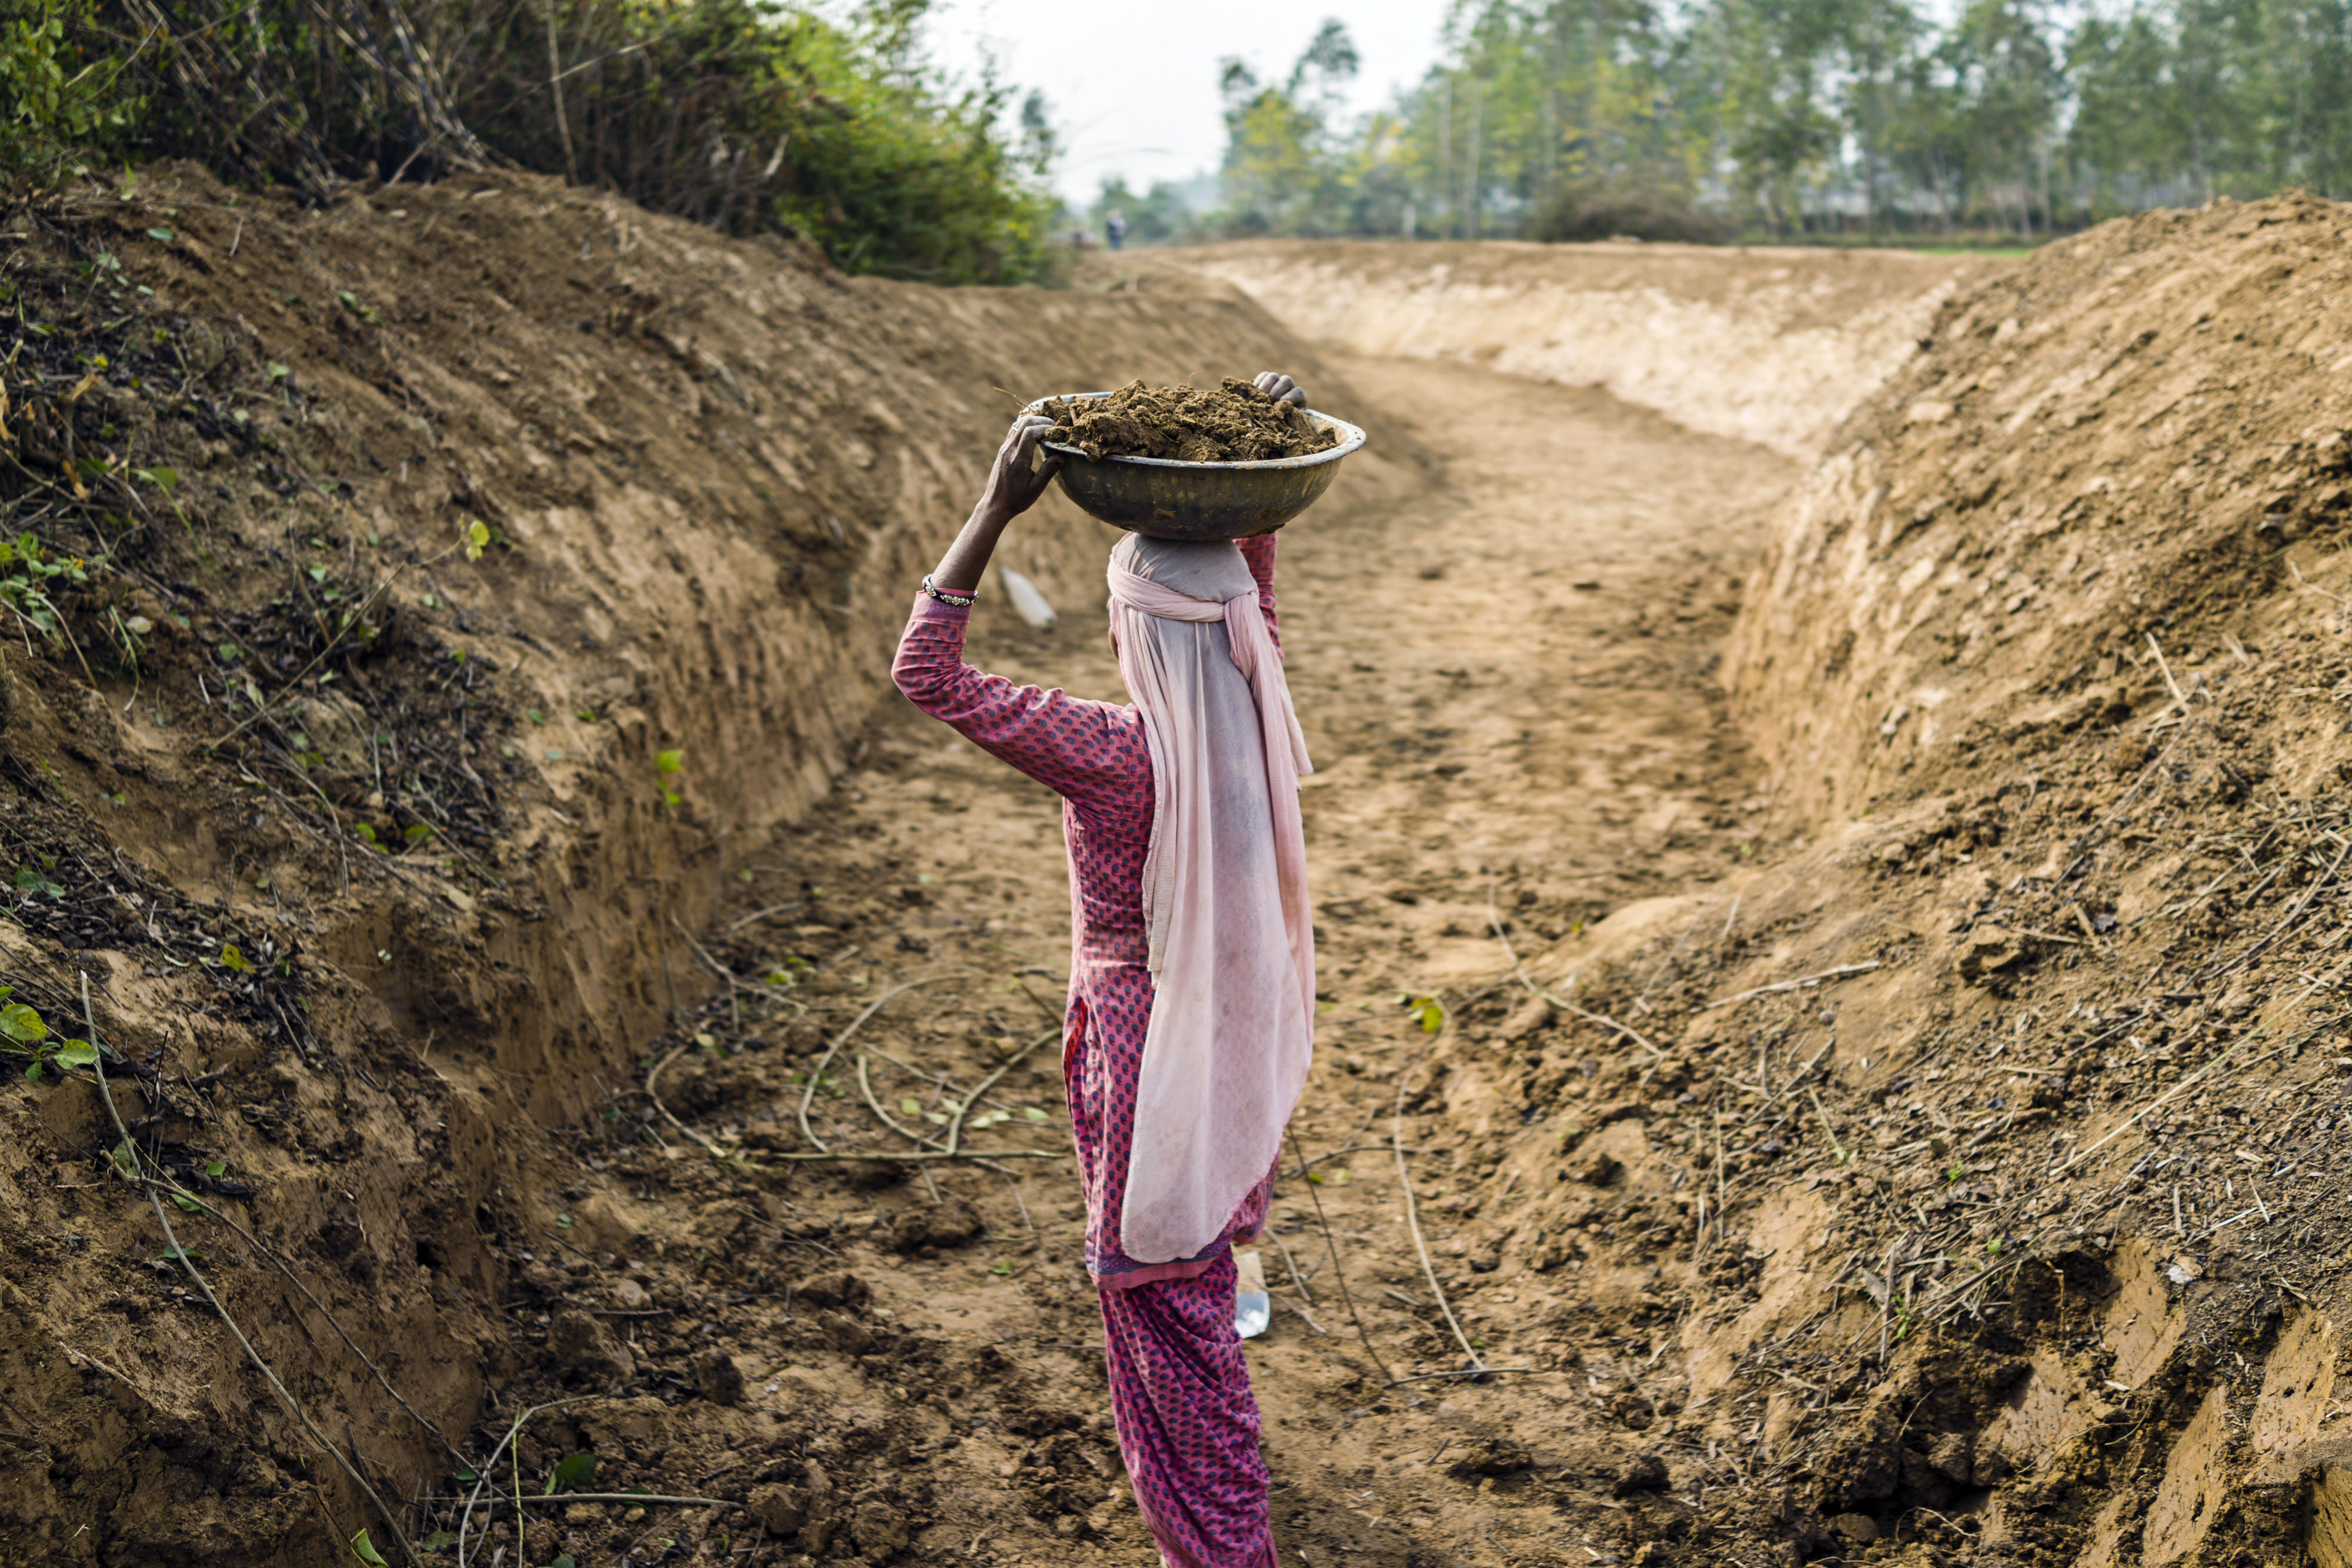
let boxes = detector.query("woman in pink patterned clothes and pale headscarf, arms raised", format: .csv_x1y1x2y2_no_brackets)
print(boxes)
894,374,1315,1568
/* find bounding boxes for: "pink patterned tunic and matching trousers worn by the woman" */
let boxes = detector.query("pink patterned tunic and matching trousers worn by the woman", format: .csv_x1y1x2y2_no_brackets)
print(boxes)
891,536,1282,1568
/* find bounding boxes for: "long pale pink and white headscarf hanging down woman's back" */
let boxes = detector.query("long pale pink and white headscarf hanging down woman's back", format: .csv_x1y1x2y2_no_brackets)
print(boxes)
1108,534,1315,1265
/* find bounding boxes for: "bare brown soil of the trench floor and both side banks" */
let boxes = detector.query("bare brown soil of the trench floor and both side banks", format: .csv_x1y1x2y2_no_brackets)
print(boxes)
14,172,2352,1568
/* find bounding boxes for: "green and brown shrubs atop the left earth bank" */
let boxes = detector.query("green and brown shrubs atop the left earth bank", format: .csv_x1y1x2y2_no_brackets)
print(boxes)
0,0,1054,282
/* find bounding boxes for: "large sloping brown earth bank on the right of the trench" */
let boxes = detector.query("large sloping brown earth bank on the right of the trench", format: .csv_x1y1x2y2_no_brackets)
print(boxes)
1374,198,2352,1563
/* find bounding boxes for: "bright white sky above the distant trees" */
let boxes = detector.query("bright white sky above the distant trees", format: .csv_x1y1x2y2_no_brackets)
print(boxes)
913,0,1449,202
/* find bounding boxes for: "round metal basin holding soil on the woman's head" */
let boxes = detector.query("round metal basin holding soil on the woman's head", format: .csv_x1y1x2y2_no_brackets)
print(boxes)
1025,393,1364,541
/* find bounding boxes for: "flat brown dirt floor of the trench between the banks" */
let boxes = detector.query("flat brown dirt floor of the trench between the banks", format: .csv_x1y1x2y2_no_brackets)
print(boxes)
482,362,1792,1568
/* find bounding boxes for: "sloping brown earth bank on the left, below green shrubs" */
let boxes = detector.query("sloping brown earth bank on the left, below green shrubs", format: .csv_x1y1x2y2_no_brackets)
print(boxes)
0,169,1418,1563
